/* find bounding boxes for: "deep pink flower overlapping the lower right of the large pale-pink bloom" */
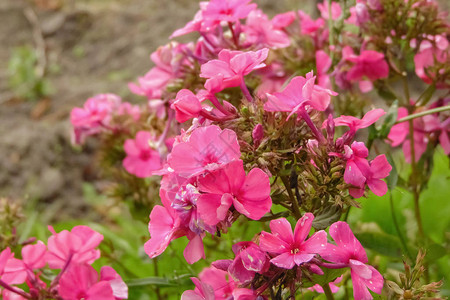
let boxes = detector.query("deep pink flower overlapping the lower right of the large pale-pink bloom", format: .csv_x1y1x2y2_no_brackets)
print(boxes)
197,160,272,225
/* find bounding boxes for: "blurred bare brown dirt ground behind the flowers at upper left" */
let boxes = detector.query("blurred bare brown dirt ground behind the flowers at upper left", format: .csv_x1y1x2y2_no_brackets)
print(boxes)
0,0,293,219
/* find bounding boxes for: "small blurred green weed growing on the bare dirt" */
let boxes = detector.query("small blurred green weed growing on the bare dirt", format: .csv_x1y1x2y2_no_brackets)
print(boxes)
8,46,52,100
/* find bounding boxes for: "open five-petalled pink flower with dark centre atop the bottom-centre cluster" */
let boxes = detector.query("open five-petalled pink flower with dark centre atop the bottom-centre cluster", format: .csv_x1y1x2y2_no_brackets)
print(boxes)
259,213,327,269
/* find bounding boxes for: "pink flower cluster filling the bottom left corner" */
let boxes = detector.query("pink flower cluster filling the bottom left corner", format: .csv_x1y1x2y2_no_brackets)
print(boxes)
0,226,128,300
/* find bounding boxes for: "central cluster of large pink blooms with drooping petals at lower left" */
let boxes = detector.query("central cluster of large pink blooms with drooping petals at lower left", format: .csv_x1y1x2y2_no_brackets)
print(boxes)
145,125,272,263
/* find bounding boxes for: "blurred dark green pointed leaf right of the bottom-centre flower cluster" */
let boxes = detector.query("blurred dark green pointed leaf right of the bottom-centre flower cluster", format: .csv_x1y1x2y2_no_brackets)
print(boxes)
355,232,402,257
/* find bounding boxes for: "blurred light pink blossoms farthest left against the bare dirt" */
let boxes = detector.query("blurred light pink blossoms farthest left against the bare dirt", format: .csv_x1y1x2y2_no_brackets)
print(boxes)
70,94,121,144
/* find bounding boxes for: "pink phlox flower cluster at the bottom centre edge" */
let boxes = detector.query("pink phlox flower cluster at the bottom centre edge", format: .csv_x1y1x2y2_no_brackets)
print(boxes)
182,213,384,300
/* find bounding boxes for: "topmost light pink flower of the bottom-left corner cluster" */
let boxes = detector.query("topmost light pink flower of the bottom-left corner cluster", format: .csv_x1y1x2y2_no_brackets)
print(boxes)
47,225,103,269
